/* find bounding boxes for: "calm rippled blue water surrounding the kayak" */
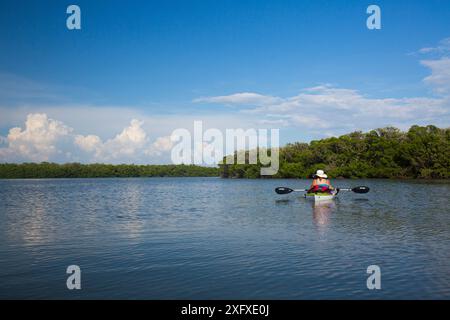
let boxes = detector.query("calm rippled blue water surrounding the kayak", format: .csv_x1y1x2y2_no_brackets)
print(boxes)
0,178,450,299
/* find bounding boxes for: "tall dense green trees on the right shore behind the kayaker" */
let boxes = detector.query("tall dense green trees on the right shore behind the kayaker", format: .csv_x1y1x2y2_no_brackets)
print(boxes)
220,126,450,179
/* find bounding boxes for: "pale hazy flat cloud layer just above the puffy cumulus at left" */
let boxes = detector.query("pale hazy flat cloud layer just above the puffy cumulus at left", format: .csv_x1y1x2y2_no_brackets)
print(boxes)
0,105,257,141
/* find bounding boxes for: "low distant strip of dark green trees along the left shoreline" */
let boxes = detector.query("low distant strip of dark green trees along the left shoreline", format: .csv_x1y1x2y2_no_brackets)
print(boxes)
0,162,219,179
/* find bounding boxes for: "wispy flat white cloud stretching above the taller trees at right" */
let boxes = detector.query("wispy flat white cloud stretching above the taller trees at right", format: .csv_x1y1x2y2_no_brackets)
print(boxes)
198,85,450,134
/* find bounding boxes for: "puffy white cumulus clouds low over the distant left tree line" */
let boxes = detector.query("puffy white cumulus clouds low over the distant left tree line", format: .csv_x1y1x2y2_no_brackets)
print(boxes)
0,113,181,163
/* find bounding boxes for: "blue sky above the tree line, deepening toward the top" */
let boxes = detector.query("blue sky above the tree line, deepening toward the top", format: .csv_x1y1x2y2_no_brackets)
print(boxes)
0,0,450,162
